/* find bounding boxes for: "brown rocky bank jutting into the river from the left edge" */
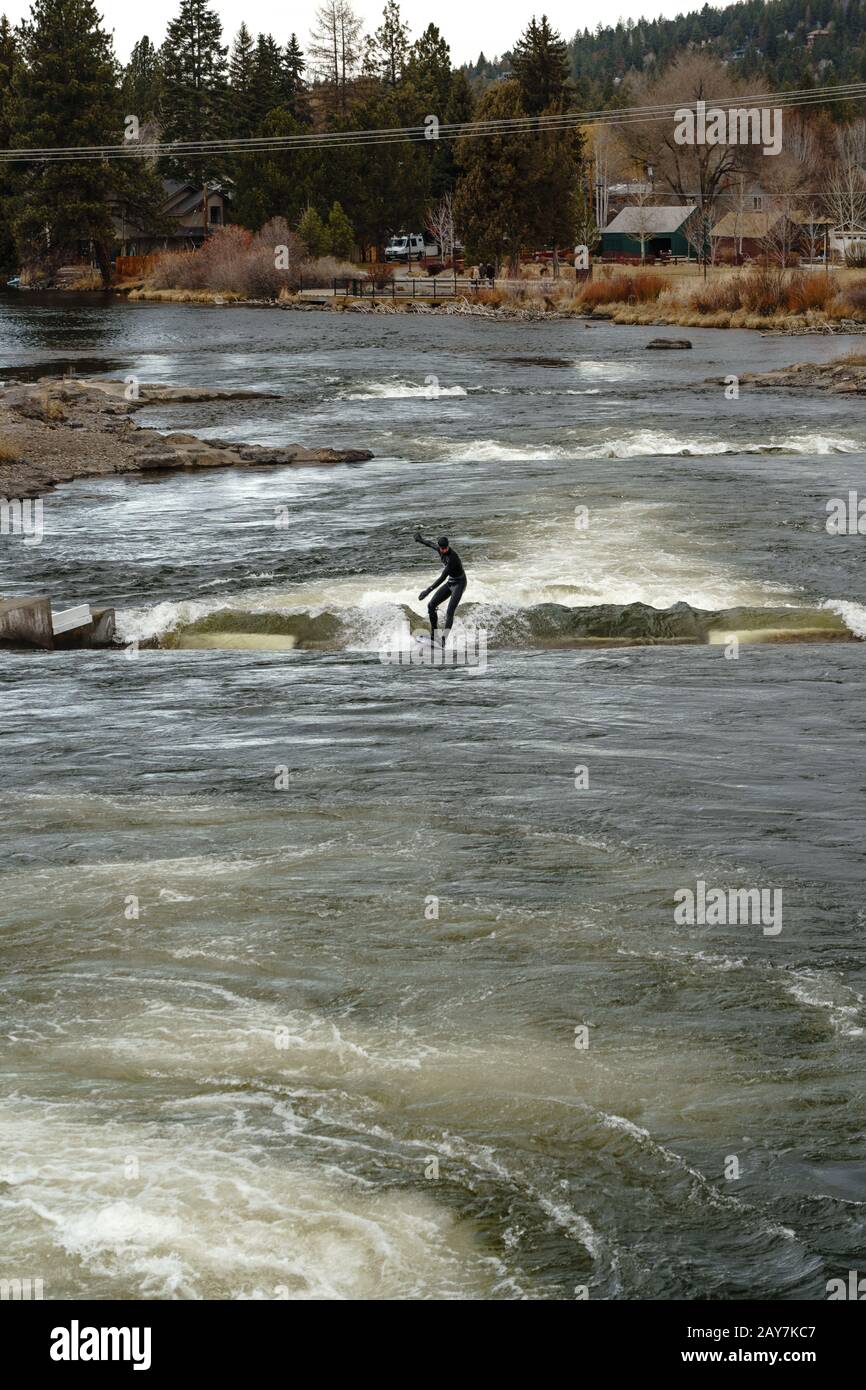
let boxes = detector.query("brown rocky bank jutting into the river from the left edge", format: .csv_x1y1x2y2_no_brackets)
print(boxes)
0,377,373,498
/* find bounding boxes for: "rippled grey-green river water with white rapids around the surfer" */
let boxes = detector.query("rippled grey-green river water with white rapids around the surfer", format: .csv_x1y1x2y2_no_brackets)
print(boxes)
0,296,866,1300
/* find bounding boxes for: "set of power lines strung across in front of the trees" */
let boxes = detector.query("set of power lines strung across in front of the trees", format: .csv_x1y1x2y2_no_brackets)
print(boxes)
0,82,866,164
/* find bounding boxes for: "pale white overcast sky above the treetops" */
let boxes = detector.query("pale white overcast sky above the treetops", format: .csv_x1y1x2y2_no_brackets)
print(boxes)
0,0,702,63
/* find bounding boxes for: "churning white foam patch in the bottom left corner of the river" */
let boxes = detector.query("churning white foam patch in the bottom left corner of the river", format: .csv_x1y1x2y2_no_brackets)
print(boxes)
1,1095,503,1300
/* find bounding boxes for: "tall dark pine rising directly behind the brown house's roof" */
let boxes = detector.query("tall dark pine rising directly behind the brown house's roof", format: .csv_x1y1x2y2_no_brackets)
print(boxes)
161,0,228,182
